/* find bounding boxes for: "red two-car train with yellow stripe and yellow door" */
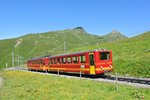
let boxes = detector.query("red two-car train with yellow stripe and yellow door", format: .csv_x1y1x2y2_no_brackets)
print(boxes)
27,50,113,75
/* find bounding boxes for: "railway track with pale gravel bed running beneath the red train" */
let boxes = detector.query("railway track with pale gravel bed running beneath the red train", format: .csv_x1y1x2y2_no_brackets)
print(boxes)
5,67,150,88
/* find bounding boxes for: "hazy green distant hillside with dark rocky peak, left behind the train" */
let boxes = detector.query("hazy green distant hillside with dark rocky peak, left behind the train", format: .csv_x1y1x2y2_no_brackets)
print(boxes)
0,27,125,68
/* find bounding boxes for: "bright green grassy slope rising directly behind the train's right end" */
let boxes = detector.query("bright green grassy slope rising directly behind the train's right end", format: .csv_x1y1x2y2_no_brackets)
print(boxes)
70,32,150,77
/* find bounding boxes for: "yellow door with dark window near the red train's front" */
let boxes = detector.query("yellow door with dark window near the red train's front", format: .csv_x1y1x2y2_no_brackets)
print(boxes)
89,53,95,74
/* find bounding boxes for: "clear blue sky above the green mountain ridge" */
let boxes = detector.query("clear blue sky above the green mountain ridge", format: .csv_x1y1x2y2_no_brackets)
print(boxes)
0,0,150,39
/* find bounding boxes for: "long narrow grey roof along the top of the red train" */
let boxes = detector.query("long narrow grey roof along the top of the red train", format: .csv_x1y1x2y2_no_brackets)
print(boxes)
30,49,110,60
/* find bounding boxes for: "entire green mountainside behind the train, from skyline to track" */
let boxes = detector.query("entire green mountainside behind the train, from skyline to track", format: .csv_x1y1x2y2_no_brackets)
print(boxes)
0,27,150,78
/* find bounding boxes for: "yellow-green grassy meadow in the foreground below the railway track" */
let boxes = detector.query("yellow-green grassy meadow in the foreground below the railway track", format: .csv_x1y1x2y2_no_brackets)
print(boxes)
0,71,150,100
